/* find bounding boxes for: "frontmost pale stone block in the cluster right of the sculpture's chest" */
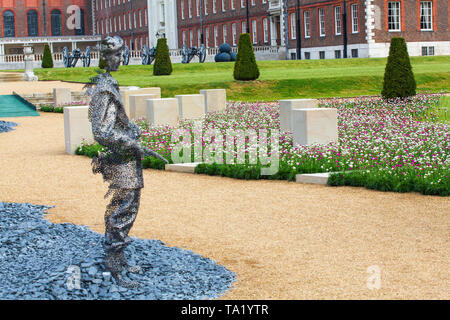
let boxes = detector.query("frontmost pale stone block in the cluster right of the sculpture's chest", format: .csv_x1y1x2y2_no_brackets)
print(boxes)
146,98,180,127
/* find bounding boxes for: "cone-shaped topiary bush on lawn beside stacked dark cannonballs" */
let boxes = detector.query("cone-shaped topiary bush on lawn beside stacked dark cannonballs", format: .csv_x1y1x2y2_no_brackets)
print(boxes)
234,33,259,81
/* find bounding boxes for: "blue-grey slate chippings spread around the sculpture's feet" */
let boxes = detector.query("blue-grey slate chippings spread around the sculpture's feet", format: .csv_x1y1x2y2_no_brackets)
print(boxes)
0,202,234,300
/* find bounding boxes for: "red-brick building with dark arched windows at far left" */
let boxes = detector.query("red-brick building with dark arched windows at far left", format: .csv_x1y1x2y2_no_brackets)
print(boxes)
0,0,97,54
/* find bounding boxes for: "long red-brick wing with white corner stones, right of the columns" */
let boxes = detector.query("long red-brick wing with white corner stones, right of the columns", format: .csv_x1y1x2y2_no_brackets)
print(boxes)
177,0,450,59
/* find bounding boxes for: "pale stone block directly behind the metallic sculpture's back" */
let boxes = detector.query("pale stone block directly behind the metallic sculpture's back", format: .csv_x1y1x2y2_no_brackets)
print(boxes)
64,106,94,154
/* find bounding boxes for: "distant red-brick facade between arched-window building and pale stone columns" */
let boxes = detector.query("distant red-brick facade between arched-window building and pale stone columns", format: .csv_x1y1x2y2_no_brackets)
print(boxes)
91,0,150,50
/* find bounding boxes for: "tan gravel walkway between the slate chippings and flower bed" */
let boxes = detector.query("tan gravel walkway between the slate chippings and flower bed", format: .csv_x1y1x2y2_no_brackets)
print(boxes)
0,113,450,299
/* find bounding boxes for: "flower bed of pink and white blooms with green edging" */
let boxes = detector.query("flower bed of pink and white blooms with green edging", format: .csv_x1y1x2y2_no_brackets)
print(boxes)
77,95,450,195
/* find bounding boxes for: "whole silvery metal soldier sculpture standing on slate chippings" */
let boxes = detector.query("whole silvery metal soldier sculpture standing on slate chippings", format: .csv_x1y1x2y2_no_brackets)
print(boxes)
87,36,167,288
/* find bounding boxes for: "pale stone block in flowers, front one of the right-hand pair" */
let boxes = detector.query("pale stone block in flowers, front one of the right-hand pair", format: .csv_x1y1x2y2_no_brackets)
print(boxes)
292,108,338,146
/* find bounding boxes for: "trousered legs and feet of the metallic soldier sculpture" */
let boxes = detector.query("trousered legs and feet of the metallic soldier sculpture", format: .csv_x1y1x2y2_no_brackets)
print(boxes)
104,189,141,287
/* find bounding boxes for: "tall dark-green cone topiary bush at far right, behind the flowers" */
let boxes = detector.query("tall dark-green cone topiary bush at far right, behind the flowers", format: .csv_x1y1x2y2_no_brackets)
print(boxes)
381,38,416,99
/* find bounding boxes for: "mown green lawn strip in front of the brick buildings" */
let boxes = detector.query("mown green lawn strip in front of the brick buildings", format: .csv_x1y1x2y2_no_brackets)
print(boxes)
30,56,450,101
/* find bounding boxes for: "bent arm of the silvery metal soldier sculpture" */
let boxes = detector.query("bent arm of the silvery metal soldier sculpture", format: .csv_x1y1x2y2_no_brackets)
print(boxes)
92,92,143,155
